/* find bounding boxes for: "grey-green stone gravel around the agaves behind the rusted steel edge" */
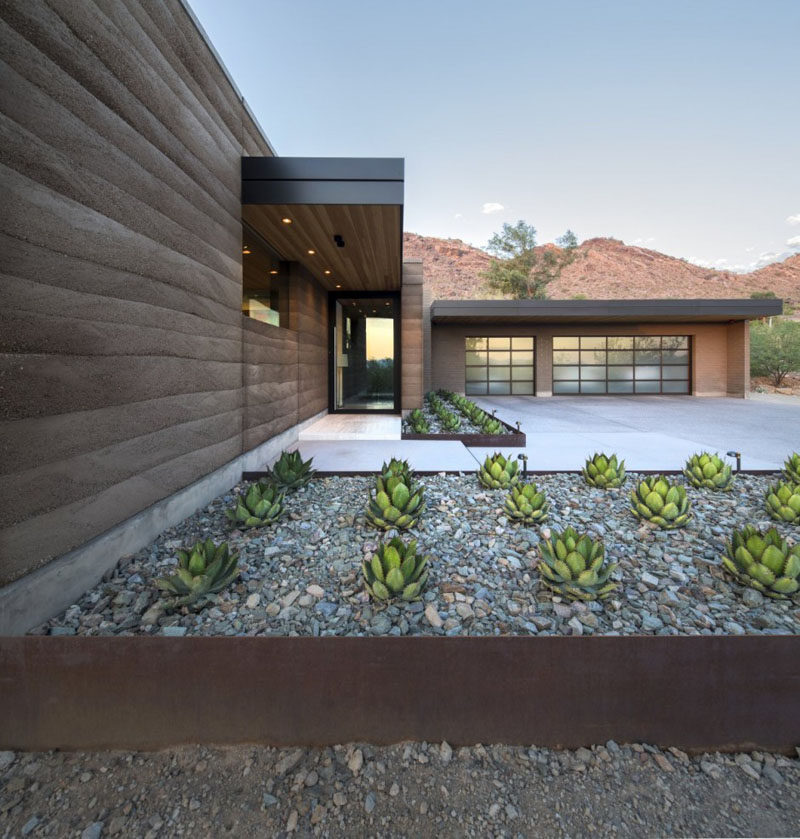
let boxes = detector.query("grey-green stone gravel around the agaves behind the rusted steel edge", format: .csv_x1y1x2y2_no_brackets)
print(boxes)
33,473,800,636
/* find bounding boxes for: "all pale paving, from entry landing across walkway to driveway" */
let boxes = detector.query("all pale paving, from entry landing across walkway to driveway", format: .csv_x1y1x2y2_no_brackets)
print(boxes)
280,396,800,472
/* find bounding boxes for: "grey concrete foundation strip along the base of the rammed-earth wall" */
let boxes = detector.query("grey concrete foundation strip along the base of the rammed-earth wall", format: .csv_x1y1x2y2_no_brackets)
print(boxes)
0,411,328,635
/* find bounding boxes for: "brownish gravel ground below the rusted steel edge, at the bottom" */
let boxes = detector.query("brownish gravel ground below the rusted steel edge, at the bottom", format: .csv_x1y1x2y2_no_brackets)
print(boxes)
0,741,800,839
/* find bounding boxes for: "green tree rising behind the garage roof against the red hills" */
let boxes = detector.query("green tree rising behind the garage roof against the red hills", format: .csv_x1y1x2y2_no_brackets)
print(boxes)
481,220,578,300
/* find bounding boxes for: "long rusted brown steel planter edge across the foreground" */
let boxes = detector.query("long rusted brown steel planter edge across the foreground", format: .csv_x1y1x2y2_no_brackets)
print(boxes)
0,636,800,751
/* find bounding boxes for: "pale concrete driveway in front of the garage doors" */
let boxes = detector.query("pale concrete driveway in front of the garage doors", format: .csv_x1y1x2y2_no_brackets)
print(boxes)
471,396,800,470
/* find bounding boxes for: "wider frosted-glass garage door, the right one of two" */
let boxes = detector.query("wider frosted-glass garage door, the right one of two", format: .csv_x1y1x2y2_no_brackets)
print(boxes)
553,335,691,395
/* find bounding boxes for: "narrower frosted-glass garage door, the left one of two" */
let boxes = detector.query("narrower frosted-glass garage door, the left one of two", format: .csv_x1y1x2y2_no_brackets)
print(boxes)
464,335,536,396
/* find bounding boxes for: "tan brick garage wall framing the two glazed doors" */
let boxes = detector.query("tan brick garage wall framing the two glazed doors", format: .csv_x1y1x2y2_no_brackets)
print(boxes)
431,321,749,397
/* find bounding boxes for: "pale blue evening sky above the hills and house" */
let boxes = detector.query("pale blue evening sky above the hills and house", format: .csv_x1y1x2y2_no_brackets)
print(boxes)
189,0,800,271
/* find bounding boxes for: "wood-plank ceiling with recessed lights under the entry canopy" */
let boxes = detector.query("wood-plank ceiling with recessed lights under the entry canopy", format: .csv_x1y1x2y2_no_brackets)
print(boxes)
242,204,403,291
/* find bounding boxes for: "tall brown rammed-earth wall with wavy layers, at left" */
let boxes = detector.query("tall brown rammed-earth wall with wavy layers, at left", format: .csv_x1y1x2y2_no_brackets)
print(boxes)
0,0,327,584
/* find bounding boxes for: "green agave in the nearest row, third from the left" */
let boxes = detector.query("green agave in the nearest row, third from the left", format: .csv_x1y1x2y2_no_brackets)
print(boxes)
538,527,617,600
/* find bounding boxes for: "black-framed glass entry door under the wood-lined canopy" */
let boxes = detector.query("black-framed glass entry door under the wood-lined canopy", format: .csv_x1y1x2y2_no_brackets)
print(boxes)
331,295,399,412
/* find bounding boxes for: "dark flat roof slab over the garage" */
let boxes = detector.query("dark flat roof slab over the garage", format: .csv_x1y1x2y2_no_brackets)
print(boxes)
431,298,783,323
